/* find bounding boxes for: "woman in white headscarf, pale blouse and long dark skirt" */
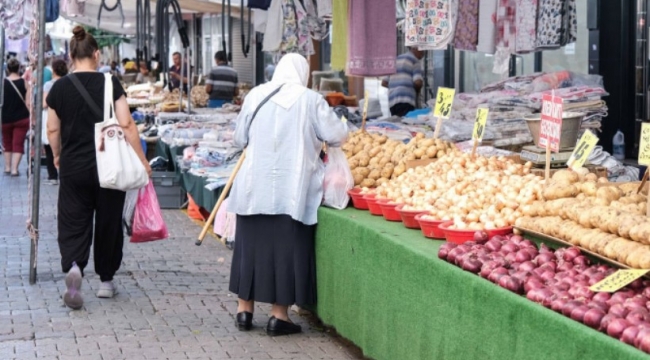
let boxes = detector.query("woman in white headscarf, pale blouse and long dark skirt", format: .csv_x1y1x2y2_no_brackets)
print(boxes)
229,54,348,336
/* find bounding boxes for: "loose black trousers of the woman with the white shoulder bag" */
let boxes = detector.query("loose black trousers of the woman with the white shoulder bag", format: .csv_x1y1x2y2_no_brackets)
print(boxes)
58,169,125,281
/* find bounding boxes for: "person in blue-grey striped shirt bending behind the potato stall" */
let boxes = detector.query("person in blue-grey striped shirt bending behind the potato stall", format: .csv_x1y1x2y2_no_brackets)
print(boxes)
381,47,424,116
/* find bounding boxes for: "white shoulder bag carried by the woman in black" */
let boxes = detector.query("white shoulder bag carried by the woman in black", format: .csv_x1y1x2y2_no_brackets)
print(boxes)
72,74,149,191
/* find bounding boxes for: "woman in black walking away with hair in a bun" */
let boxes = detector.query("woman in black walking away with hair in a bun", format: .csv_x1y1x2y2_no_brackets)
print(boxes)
46,26,151,309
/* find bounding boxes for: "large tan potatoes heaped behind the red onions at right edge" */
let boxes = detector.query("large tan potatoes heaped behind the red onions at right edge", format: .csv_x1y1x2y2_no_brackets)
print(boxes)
516,170,650,269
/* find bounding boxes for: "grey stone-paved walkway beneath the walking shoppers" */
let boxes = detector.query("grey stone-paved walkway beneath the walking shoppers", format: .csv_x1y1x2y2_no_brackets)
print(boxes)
0,160,362,360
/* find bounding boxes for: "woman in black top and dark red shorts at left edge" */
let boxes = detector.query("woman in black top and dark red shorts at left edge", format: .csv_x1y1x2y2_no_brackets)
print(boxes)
2,59,29,176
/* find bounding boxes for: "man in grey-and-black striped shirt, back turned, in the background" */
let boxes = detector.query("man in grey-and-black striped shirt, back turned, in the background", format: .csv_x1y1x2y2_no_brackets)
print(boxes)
205,51,239,108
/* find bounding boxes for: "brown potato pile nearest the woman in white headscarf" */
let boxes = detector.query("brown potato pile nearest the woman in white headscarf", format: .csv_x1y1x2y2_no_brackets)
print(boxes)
342,131,455,187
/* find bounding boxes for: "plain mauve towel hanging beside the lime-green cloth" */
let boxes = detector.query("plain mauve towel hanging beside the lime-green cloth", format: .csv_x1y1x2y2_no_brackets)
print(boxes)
347,0,397,76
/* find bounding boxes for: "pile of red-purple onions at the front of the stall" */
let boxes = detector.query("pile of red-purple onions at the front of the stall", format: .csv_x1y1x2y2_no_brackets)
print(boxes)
438,232,650,353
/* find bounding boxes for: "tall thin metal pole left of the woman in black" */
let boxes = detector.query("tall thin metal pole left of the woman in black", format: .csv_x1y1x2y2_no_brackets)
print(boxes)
29,0,45,284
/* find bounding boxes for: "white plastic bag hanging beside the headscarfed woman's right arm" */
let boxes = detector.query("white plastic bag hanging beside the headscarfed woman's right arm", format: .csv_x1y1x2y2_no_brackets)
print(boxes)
323,148,354,210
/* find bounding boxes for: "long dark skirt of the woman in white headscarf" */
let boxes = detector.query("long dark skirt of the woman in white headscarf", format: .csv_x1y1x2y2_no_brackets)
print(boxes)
230,215,316,306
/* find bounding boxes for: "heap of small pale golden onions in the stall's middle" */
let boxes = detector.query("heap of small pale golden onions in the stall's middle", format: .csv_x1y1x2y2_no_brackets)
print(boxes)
375,151,544,230
